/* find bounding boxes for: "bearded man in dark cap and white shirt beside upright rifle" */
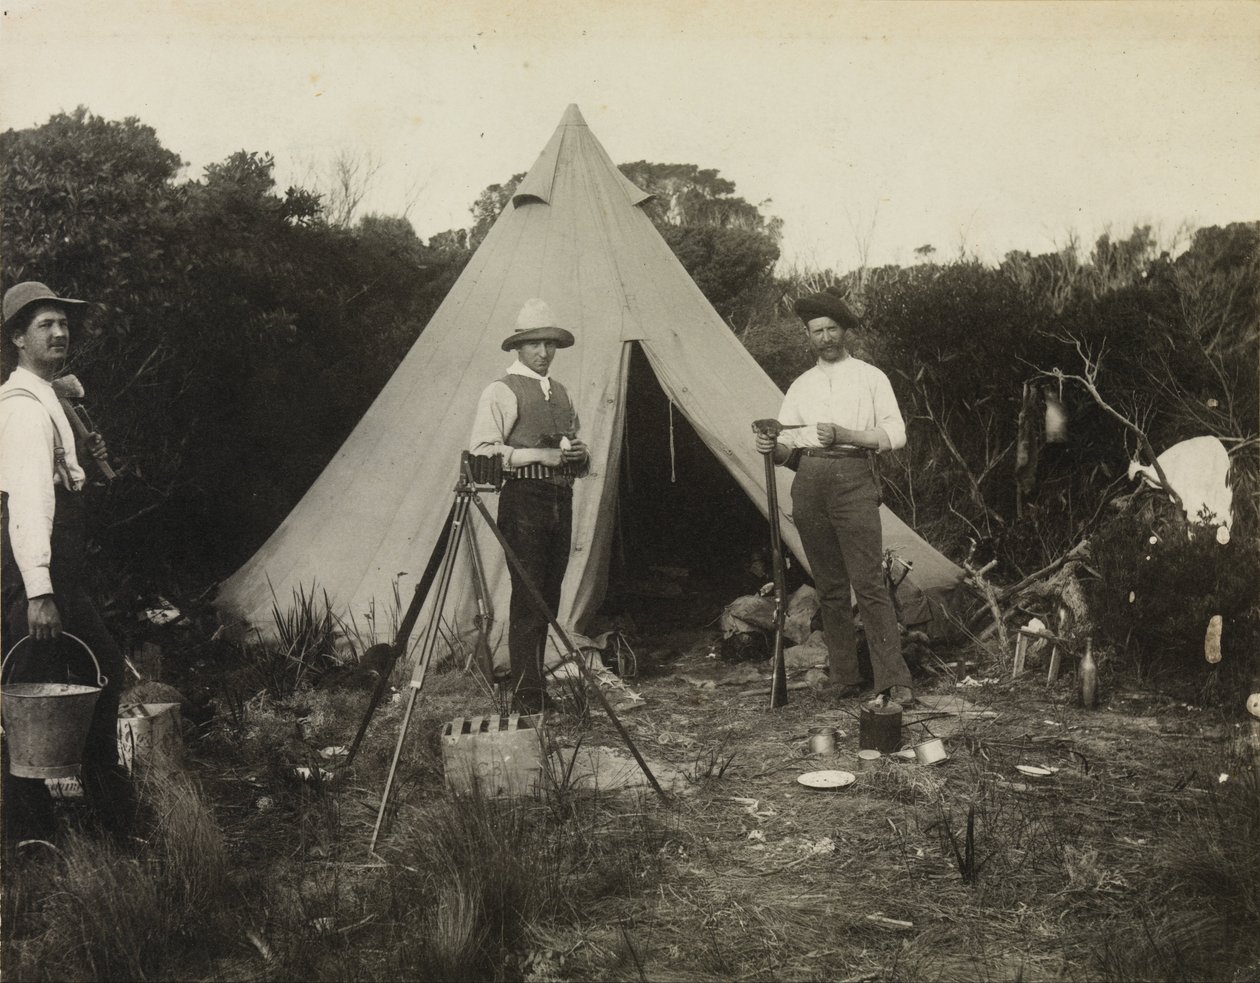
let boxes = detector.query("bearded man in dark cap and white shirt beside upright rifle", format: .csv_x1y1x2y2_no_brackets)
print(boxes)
757,287,914,704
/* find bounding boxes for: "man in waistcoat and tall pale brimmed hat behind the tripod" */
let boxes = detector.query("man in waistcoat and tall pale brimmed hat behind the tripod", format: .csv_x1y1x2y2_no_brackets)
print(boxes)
469,297,590,713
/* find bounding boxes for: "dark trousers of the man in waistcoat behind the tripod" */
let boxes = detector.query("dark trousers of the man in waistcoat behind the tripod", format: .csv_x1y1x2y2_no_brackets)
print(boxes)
499,478,573,696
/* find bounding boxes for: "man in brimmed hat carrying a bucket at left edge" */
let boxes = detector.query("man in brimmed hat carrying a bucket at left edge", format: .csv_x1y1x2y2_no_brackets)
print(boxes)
0,281,132,843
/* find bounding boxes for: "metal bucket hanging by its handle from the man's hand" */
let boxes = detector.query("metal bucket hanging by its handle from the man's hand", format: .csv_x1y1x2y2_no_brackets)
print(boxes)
0,631,108,779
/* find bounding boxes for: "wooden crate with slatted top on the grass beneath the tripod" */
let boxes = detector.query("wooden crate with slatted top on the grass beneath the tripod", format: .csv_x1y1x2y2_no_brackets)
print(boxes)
442,713,543,795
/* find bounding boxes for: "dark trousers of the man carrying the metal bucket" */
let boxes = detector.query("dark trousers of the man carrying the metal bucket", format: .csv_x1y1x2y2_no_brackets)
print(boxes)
0,488,134,841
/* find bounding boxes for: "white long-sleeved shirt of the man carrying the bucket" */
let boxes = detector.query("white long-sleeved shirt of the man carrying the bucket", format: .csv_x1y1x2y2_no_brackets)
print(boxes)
0,365,84,597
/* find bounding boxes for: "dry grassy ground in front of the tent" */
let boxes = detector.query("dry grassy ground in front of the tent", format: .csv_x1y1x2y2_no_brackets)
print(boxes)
4,625,1260,980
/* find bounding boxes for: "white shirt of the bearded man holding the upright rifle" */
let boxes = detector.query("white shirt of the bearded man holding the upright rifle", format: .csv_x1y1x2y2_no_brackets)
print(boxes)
779,355,906,451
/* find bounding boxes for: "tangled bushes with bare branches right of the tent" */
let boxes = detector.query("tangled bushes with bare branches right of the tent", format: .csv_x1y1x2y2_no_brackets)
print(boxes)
811,223,1260,665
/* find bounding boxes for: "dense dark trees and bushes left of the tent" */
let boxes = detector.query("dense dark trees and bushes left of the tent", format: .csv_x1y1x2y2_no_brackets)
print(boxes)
0,108,455,592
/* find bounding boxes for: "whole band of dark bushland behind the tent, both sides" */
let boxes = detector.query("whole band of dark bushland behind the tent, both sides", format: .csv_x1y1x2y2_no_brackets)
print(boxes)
0,108,1260,675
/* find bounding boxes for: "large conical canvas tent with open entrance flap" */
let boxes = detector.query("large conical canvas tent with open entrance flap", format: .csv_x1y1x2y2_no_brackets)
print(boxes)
217,106,961,660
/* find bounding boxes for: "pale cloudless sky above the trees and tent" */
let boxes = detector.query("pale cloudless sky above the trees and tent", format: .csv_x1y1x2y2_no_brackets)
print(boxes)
0,0,1260,270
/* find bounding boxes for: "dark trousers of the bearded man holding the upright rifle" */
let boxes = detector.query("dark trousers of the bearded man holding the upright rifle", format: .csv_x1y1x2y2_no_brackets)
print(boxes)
791,457,911,692
